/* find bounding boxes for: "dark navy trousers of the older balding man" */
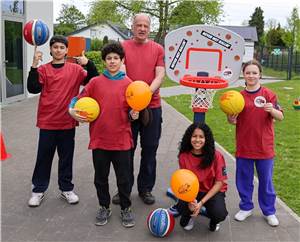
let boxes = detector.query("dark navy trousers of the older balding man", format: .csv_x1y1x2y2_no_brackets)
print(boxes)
131,107,162,193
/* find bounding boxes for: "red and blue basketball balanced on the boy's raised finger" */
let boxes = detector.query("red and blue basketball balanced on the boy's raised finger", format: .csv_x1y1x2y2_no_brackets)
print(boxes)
23,19,49,45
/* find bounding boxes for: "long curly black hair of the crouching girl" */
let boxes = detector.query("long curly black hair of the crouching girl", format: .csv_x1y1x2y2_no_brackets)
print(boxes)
178,123,216,169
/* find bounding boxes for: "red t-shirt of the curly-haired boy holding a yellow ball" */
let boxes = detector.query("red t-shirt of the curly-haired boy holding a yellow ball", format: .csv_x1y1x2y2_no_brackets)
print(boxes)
78,75,133,150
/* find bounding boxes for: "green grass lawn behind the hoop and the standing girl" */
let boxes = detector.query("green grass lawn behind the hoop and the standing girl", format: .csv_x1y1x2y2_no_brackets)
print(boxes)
164,80,300,215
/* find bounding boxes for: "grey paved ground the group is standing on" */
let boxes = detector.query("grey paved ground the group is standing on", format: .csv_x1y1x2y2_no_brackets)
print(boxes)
1,86,300,242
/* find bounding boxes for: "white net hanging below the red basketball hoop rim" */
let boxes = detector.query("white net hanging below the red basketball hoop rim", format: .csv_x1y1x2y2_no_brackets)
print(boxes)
192,88,216,112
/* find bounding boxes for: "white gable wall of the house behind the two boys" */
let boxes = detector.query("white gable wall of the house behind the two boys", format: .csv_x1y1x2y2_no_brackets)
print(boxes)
72,24,124,41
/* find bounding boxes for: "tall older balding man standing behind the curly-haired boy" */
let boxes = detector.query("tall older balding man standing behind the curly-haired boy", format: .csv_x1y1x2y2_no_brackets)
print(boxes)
113,13,165,204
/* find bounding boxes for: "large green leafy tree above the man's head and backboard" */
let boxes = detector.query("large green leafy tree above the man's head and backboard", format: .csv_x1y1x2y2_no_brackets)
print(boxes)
89,0,222,43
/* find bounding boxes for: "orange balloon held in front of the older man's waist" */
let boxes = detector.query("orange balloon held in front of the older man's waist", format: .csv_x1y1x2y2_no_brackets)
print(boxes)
125,81,152,111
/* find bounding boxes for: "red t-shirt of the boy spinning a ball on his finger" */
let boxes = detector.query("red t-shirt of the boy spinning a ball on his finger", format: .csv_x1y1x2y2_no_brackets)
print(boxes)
37,62,87,130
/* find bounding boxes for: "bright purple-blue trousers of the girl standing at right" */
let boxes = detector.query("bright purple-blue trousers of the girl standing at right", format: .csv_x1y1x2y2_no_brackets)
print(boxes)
235,158,276,216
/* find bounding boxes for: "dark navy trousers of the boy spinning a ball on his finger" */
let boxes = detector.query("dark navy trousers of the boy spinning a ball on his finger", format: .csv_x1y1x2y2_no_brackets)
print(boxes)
32,128,75,192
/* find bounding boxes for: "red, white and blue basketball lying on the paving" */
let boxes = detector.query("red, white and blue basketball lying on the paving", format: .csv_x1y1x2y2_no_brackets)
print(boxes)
147,208,175,237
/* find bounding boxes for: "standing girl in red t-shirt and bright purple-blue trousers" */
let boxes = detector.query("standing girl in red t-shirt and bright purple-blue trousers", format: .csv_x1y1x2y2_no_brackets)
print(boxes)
228,60,284,226
